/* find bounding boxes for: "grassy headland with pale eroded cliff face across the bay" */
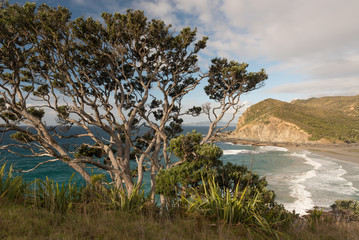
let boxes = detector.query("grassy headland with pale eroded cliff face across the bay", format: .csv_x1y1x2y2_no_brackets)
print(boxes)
231,95,359,143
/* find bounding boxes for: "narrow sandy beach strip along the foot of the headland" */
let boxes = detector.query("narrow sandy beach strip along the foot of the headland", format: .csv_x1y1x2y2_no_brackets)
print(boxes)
214,135,359,164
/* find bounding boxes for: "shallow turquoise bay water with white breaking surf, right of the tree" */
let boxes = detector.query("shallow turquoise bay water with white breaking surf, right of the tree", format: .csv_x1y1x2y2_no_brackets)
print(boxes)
218,143,359,214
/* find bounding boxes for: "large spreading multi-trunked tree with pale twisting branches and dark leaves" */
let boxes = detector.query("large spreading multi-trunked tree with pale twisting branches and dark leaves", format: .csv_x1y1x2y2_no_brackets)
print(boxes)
0,1,267,199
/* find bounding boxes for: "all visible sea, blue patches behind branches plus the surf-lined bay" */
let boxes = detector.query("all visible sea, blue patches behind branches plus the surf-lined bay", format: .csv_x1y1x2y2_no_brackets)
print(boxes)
0,126,359,214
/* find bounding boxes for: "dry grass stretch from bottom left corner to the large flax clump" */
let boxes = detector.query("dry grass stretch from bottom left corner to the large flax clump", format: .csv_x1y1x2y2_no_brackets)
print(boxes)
0,201,250,240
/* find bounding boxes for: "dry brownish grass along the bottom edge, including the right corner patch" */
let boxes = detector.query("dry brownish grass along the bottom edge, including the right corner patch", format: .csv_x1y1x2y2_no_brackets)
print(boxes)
0,201,359,240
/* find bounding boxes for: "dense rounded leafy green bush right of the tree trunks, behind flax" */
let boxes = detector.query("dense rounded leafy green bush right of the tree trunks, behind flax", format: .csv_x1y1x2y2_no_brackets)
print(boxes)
156,131,275,204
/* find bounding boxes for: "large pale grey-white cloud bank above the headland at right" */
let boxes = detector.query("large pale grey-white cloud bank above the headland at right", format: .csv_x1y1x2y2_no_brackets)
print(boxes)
215,0,359,99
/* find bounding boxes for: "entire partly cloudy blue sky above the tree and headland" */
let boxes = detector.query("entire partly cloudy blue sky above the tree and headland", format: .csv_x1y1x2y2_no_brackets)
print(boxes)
9,0,359,124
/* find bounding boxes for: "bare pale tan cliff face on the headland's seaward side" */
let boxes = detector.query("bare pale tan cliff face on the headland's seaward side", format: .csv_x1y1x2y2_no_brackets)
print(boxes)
230,115,310,143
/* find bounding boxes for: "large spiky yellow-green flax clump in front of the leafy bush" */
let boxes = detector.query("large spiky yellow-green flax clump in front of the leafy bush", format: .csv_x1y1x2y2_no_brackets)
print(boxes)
184,178,296,235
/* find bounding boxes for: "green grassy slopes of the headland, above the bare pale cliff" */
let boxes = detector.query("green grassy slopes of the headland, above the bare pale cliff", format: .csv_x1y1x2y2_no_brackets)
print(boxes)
243,95,359,143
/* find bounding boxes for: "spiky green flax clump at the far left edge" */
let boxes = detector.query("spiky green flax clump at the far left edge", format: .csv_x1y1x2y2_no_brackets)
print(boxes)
0,164,31,201
